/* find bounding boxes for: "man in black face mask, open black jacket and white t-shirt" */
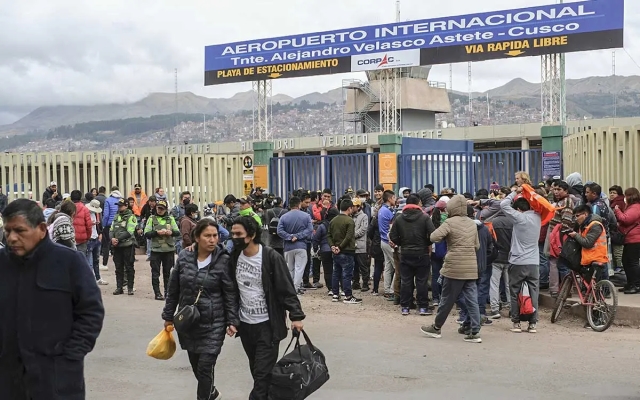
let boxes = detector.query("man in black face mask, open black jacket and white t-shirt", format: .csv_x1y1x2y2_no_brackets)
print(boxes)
227,216,305,400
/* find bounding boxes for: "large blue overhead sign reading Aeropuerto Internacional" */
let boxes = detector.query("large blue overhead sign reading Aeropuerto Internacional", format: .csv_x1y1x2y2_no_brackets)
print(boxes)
205,0,624,85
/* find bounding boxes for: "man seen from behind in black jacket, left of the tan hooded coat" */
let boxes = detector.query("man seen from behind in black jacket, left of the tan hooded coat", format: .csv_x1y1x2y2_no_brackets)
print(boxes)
389,194,436,315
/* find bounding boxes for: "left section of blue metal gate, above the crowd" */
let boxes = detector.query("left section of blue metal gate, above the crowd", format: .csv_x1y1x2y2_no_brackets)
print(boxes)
269,153,378,198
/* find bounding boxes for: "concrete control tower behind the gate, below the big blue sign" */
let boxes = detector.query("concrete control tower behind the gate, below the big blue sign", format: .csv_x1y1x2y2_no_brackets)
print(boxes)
342,66,451,133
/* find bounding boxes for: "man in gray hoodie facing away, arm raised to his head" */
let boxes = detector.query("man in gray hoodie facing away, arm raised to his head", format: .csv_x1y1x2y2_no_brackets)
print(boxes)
500,188,542,333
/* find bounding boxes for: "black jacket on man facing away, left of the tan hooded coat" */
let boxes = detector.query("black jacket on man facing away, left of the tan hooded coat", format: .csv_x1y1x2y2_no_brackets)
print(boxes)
389,204,436,256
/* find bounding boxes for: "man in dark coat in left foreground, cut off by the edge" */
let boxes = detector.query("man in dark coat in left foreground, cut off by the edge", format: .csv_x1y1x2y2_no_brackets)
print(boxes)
0,199,104,400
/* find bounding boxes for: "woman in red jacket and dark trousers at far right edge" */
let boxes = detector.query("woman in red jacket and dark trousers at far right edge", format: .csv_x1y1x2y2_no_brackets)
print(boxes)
613,188,640,294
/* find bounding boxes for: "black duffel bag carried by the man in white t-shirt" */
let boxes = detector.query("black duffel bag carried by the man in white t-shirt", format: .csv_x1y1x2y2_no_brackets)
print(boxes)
269,330,329,400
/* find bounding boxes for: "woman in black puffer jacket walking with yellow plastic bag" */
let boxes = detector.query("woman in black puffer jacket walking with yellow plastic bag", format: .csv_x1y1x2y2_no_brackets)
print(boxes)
162,218,240,400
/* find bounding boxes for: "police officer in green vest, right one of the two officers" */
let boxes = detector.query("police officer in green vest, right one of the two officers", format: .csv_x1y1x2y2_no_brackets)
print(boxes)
144,200,180,300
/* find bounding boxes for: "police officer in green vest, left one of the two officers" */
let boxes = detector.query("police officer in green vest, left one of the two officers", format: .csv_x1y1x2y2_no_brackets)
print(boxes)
110,199,138,296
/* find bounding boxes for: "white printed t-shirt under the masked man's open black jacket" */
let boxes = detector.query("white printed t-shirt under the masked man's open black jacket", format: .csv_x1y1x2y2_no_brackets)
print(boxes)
236,245,269,324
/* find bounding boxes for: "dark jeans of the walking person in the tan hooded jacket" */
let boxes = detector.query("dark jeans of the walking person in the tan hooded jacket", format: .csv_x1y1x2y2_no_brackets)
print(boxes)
434,277,480,334
